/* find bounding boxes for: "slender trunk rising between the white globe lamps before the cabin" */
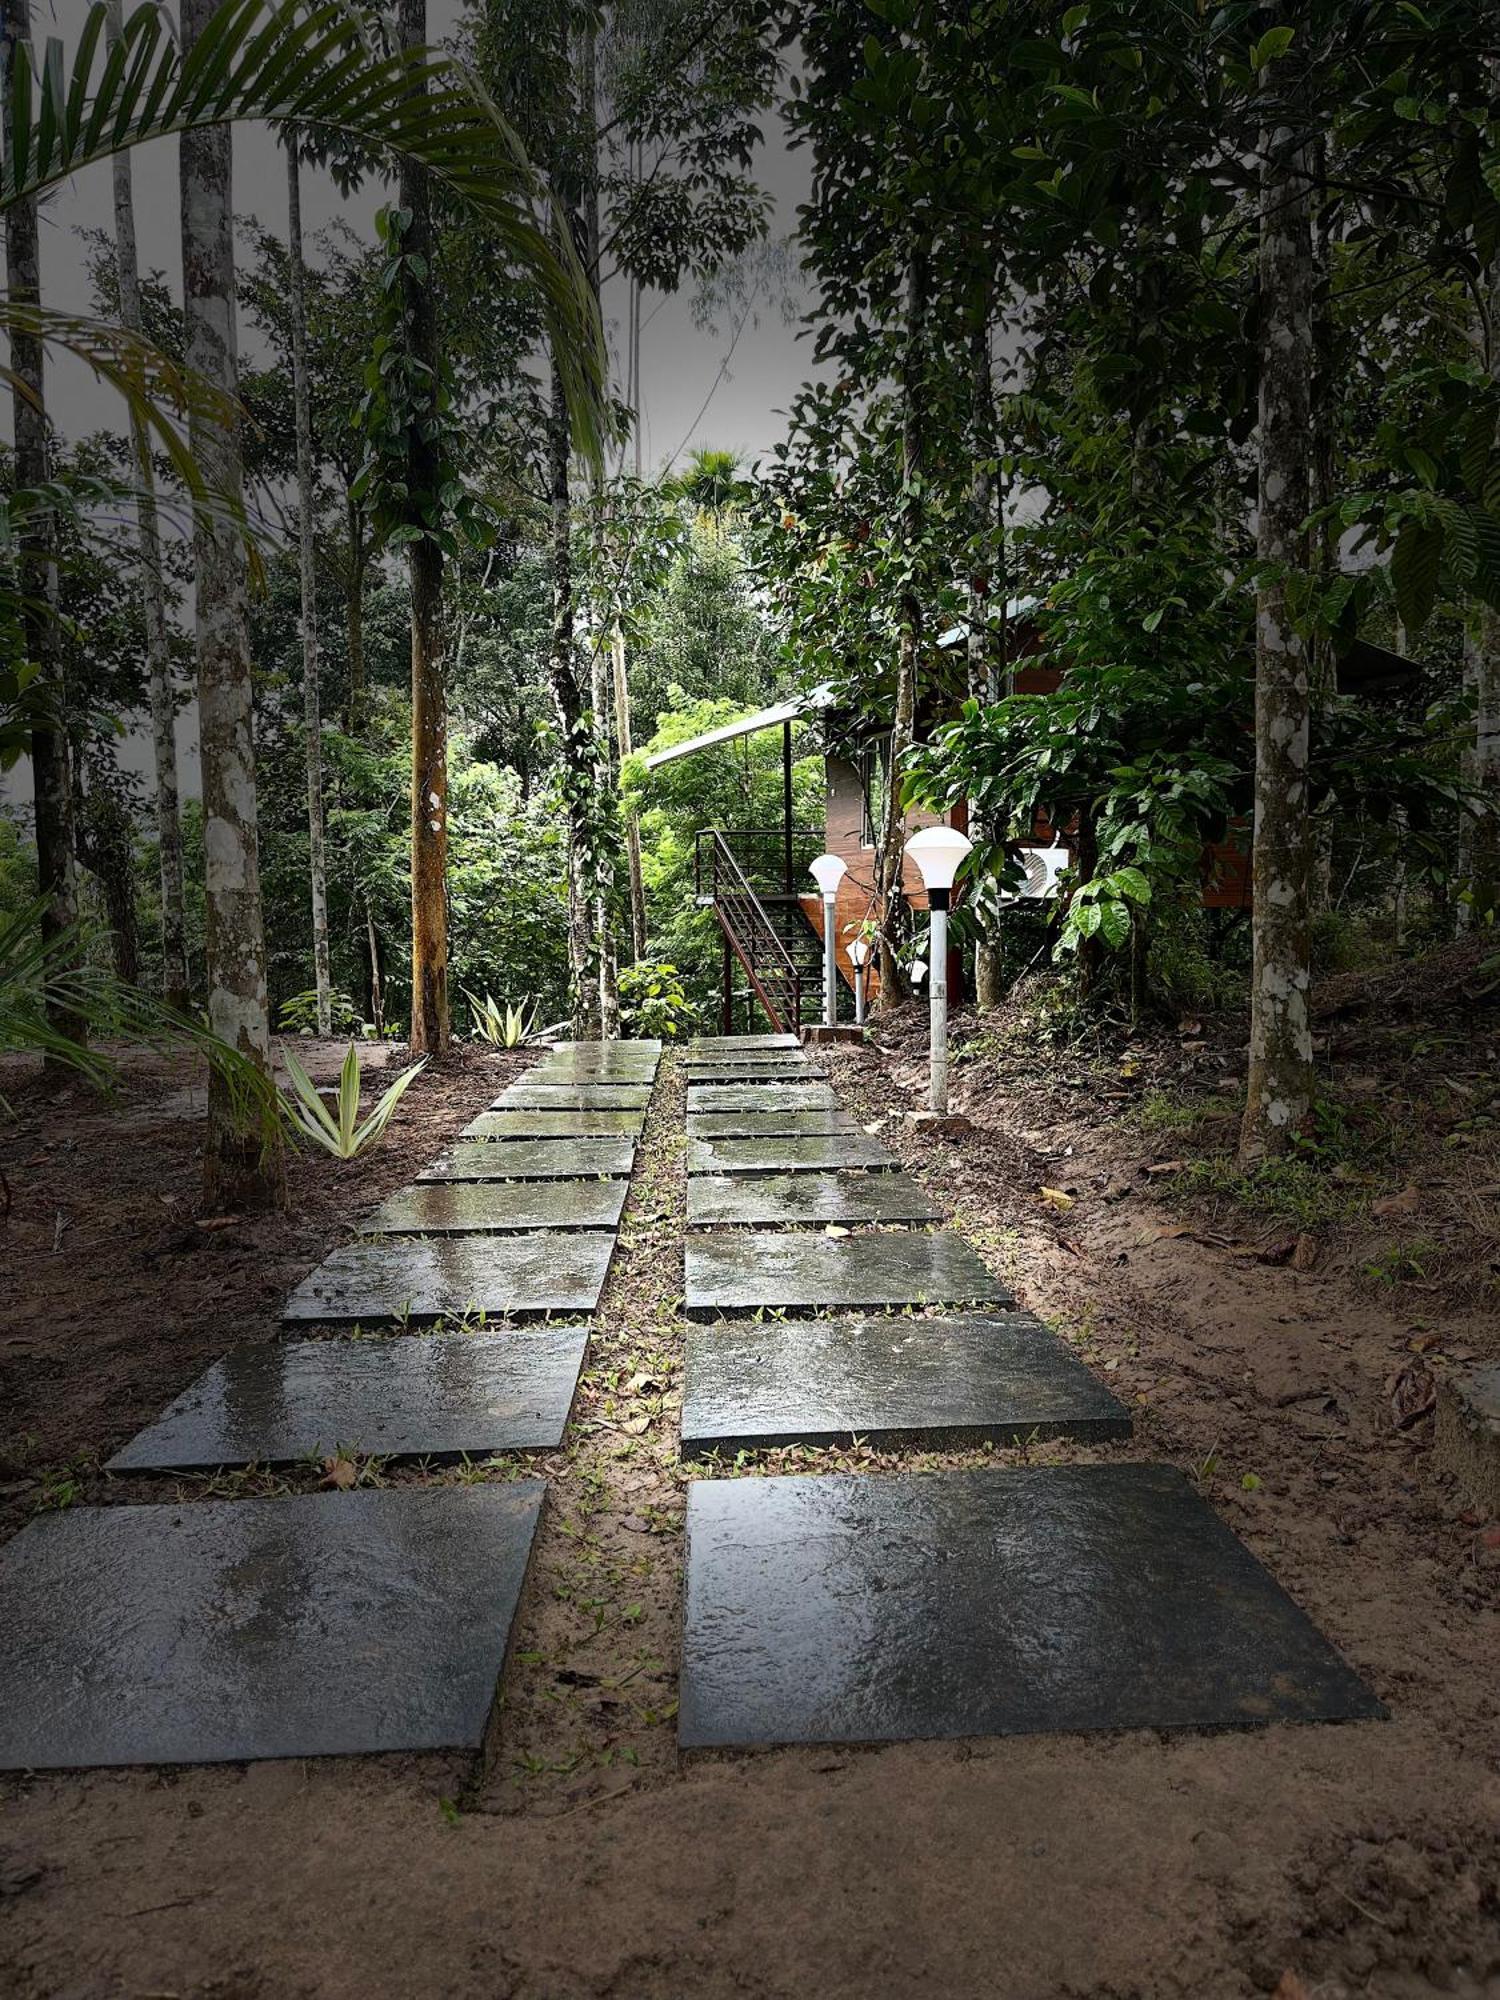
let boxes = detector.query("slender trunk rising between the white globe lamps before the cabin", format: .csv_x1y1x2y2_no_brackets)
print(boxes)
880,242,930,1006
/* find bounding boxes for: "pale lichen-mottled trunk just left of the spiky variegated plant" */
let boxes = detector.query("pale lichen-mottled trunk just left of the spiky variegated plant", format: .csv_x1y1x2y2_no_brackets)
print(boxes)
178,0,286,1208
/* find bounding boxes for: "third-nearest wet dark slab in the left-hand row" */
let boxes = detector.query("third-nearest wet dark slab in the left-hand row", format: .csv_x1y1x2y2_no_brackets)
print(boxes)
282,1230,614,1326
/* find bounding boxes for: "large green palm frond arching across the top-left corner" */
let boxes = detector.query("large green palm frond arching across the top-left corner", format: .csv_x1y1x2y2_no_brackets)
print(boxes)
0,0,604,452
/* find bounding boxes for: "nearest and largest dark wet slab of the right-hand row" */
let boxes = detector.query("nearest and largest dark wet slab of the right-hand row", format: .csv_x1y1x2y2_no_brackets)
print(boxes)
678,1466,1384,1746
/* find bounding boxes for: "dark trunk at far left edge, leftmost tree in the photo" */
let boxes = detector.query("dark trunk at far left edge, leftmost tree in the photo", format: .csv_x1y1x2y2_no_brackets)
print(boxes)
4,0,86,1042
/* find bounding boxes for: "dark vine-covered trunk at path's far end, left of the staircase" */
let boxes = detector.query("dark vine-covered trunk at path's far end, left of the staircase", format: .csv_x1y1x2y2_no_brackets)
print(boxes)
546,346,600,1040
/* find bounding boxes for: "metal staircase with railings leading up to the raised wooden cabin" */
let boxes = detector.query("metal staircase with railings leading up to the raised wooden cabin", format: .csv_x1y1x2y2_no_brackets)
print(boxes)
696,828,822,1034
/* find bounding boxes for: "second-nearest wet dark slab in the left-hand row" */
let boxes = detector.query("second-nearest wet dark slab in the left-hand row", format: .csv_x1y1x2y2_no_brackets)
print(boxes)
106,1326,588,1472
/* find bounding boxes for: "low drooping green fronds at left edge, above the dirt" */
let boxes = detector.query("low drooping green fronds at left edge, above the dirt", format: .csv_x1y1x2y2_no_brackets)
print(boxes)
0,898,276,1130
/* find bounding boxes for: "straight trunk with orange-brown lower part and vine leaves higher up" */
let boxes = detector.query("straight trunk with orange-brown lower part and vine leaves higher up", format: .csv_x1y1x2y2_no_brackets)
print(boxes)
400,0,448,1060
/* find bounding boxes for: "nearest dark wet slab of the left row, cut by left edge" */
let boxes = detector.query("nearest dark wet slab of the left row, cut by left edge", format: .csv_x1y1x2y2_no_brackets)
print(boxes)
0,1480,546,1770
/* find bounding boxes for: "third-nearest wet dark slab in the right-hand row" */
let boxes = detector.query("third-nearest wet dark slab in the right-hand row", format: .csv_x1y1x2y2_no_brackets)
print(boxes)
692,1230,1014,1320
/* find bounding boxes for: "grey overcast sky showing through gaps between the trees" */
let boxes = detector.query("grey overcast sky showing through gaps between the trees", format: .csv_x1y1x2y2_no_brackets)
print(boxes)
0,0,824,804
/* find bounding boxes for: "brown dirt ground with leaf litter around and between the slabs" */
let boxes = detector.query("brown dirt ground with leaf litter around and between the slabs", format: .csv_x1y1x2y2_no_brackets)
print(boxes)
0,994,1500,2000
